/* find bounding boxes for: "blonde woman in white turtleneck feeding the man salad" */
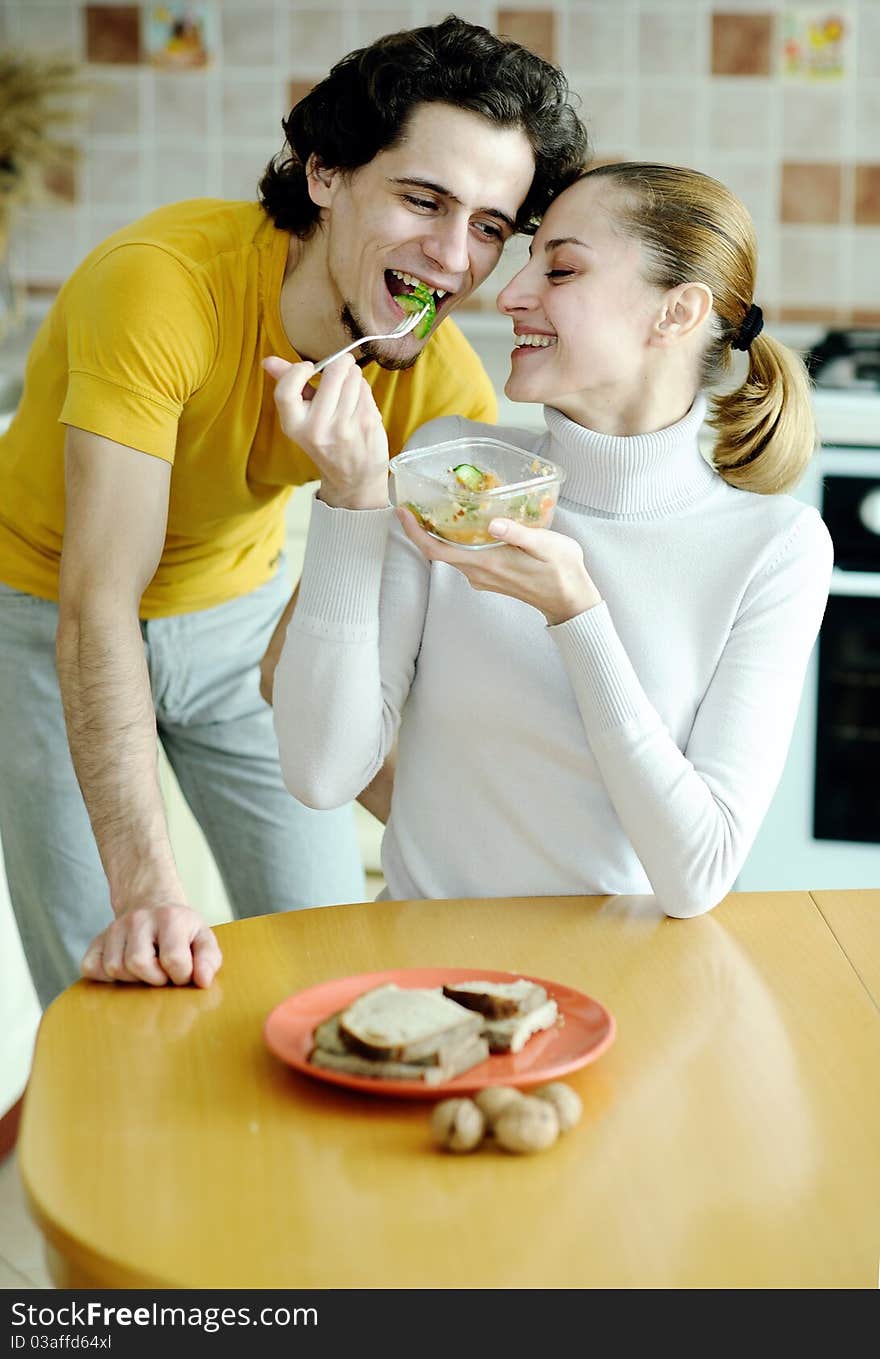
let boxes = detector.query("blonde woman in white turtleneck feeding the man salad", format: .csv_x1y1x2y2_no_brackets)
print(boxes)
268,163,831,916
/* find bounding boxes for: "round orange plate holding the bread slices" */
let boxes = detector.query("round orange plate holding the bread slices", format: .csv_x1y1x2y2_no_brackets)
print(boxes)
263,968,615,1099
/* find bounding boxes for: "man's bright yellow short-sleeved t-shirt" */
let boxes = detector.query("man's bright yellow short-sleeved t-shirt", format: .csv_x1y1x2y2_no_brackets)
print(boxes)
0,198,497,618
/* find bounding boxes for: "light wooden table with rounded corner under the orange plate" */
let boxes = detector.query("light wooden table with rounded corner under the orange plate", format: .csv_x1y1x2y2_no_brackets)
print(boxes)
19,892,880,1288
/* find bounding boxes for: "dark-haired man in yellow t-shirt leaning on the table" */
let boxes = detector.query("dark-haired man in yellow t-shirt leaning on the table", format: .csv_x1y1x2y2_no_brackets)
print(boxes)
0,18,587,1004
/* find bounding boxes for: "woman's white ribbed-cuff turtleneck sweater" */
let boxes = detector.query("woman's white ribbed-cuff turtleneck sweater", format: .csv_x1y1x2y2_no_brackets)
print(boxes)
274,395,831,916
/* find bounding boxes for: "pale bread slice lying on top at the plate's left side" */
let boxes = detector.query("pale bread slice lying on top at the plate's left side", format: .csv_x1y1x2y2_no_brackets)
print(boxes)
340,983,481,1065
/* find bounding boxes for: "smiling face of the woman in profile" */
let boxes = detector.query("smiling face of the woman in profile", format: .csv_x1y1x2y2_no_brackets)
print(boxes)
498,177,663,419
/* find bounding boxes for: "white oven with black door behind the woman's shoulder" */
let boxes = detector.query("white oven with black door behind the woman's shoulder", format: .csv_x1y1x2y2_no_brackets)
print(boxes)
736,387,880,892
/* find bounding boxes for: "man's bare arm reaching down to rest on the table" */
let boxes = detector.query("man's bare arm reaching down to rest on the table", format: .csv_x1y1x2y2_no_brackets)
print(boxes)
56,428,220,985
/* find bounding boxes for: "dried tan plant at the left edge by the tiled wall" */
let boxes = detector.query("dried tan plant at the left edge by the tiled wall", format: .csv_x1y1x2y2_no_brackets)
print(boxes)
0,50,87,245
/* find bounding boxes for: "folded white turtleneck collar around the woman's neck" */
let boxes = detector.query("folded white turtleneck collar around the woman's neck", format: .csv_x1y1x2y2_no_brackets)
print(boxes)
542,393,717,519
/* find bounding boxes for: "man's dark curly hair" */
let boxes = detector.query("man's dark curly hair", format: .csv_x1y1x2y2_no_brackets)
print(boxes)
259,15,589,239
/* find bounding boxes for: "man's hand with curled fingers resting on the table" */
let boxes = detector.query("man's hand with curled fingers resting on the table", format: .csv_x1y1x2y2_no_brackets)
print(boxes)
80,904,223,987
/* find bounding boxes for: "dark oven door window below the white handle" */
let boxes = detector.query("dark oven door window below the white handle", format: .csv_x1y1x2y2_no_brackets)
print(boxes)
813,594,880,841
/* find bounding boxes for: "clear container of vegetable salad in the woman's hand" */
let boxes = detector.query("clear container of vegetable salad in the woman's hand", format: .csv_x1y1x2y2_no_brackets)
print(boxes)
391,438,565,550
